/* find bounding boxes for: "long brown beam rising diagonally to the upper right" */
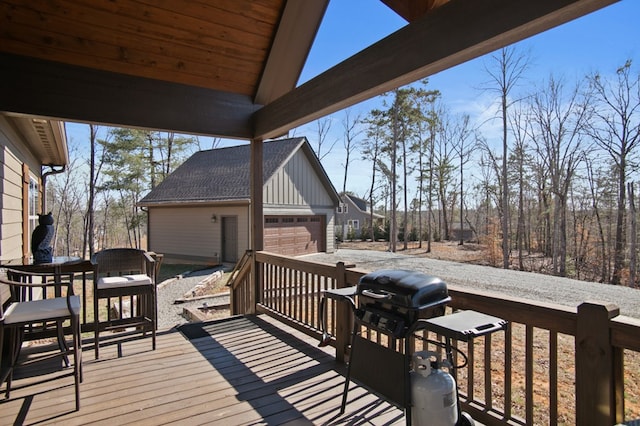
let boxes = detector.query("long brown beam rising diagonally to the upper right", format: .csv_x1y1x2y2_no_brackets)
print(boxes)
254,0,618,139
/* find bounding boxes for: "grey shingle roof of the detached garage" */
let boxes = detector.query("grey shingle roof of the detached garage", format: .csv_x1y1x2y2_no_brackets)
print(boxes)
140,137,305,205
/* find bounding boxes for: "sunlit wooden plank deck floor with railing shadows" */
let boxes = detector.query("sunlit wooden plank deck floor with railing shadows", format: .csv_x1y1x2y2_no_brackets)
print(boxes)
0,315,404,426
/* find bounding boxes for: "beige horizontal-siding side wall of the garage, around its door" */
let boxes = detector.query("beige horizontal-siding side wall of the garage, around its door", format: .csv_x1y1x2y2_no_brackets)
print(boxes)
148,205,249,263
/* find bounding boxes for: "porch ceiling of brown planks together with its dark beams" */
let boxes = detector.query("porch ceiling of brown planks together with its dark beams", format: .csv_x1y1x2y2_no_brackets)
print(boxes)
0,0,615,143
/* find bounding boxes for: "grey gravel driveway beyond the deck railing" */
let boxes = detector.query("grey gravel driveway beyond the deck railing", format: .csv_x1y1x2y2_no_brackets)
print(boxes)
304,249,640,318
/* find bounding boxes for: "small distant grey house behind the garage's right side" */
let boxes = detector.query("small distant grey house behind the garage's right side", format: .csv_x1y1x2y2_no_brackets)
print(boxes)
336,193,384,240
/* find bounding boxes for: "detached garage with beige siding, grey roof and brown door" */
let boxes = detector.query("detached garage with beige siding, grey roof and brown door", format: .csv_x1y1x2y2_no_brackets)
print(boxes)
140,137,339,263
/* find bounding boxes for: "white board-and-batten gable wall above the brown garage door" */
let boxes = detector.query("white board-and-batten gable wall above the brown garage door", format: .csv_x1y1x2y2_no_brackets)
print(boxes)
263,150,335,253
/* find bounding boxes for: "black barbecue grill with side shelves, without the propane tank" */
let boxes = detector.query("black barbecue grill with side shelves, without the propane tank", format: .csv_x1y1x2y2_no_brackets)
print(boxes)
319,269,506,424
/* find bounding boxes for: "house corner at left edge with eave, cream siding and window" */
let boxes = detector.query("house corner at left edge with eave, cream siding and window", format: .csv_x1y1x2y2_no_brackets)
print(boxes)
0,113,69,265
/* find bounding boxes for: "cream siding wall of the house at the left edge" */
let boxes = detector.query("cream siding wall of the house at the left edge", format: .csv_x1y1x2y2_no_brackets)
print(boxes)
0,116,41,264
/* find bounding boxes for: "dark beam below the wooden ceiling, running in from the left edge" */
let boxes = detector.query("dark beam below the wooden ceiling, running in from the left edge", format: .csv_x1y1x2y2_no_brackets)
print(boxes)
0,53,259,139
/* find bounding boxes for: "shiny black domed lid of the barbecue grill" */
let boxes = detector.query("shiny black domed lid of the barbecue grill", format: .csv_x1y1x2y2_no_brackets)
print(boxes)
358,269,449,309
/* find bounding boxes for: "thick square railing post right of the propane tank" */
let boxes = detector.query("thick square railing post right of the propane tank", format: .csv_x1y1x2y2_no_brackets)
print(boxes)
575,302,620,426
